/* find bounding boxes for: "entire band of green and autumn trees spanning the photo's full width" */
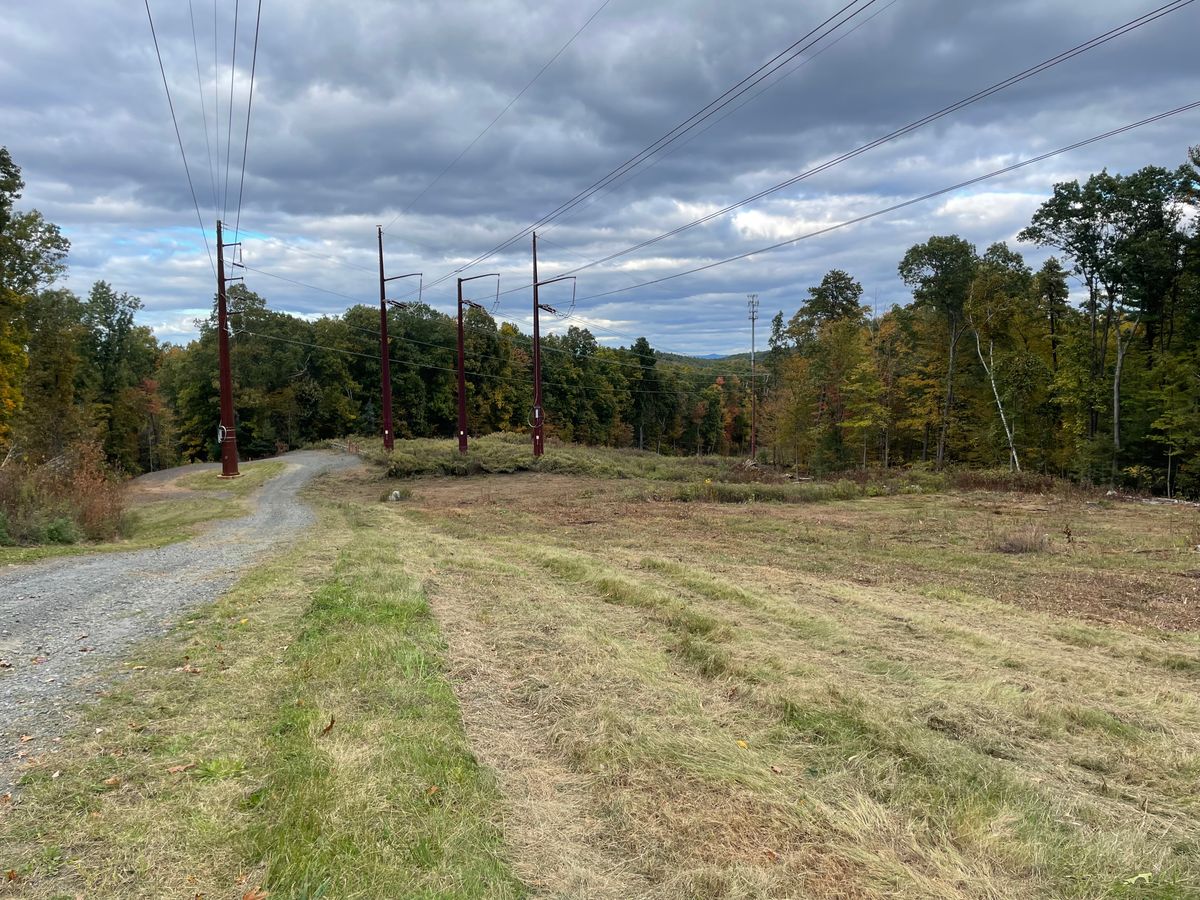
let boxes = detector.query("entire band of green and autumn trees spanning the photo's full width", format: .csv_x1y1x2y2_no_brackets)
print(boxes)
0,149,1200,494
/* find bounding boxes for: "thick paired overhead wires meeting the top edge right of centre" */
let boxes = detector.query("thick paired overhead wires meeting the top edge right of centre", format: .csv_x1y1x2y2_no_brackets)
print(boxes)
408,0,880,300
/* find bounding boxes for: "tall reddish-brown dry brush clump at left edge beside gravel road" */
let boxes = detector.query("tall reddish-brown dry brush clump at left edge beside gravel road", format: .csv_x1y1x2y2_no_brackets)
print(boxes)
0,442,125,545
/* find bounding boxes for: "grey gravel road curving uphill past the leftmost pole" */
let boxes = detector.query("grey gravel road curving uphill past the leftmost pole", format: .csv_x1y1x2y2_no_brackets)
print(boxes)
0,451,358,793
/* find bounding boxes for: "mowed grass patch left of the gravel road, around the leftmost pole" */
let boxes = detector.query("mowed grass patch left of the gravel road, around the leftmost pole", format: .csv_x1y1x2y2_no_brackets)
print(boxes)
0,461,287,565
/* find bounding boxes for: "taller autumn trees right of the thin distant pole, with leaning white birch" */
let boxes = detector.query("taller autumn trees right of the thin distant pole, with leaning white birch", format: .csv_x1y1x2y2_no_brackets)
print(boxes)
764,148,1200,496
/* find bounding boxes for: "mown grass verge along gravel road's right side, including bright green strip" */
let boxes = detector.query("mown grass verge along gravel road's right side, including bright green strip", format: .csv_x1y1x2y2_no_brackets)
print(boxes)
0,487,523,899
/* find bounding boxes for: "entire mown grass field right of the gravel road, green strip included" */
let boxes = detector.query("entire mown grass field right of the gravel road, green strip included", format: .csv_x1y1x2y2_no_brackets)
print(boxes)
0,446,1200,899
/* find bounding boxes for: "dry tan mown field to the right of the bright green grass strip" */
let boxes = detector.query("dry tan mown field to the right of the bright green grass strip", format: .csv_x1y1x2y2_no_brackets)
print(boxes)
347,460,1200,898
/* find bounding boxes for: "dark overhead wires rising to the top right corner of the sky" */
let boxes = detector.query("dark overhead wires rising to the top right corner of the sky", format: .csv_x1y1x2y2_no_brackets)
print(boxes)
549,0,1195,275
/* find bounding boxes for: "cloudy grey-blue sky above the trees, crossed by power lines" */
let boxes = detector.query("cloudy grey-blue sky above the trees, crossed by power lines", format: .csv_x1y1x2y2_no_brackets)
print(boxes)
0,0,1200,354
